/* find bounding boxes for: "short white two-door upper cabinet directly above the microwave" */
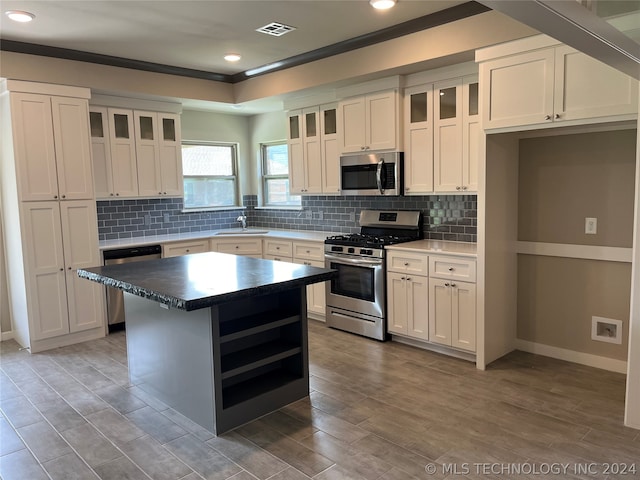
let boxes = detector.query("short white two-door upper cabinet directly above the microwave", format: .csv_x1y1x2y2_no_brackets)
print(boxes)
338,89,400,153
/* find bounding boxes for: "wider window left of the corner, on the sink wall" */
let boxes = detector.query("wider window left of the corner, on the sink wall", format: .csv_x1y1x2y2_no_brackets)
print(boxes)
182,142,238,209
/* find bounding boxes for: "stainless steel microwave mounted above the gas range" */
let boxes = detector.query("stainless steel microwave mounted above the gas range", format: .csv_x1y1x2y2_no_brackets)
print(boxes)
340,152,404,196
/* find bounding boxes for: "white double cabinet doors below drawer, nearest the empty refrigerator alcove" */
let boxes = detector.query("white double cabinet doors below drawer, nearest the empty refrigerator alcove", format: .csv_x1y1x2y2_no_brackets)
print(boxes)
429,278,476,352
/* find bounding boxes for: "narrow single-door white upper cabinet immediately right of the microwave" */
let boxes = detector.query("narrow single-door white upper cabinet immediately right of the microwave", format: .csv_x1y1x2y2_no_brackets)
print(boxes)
404,85,433,195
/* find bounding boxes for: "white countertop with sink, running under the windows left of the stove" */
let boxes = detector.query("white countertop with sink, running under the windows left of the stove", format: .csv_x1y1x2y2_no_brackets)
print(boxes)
99,227,339,250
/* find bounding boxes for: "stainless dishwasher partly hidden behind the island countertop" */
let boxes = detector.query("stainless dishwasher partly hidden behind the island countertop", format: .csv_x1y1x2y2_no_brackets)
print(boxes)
102,245,162,333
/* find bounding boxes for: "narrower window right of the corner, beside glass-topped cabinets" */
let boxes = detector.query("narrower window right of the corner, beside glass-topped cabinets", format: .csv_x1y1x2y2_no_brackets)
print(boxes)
262,142,301,207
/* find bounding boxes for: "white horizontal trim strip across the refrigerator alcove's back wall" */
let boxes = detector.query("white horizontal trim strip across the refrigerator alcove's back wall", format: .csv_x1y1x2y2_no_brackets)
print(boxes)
516,242,633,263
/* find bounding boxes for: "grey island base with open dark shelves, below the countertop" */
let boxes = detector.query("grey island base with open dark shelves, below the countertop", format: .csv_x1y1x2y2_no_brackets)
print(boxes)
125,286,309,435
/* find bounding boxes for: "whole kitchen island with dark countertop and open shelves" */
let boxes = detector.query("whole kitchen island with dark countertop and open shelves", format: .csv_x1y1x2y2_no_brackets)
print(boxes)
78,252,335,435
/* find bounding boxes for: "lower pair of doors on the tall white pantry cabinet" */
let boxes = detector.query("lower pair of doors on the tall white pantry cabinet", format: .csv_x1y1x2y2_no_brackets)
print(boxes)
22,200,104,340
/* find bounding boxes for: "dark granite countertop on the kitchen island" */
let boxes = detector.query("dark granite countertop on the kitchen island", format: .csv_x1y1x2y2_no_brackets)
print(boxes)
78,252,336,311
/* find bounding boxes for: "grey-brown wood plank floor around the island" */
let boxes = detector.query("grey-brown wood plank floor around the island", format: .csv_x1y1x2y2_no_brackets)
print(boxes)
0,322,640,480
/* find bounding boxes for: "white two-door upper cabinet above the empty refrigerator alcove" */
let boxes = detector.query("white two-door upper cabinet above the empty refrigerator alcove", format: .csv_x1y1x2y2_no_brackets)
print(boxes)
480,39,638,129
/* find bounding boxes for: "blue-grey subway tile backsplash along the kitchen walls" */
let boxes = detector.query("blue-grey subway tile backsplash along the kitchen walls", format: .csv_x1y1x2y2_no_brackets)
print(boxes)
97,195,477,242
